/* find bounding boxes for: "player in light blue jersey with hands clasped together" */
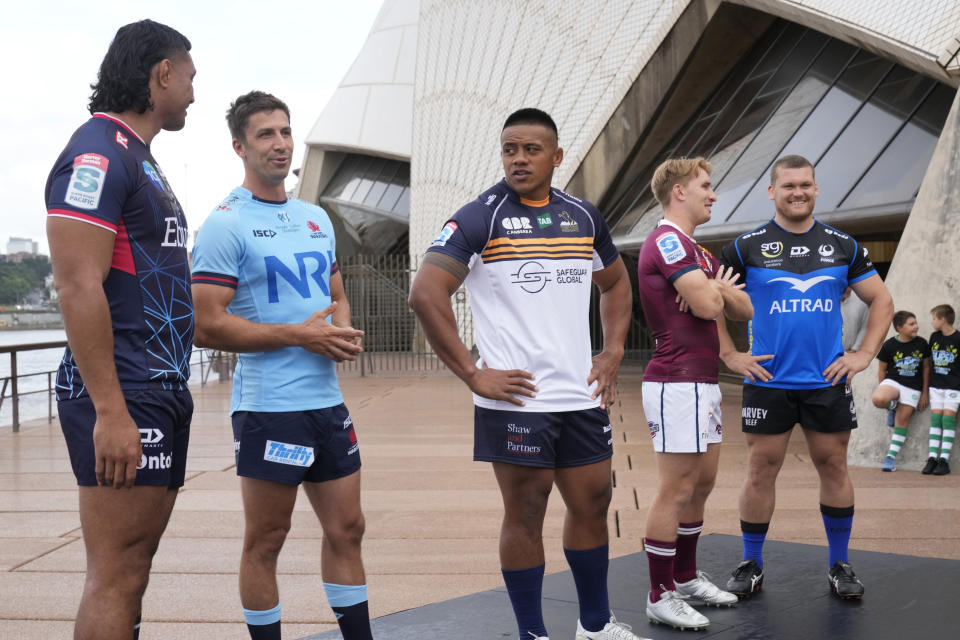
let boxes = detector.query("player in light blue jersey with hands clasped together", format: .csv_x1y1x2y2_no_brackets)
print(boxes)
193,91,371,640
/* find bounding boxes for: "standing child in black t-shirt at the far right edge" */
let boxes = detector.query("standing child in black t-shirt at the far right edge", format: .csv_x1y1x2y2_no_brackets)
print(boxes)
923,304,960,476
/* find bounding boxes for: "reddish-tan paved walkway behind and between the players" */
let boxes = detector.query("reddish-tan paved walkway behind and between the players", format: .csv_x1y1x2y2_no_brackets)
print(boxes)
0,373,960,640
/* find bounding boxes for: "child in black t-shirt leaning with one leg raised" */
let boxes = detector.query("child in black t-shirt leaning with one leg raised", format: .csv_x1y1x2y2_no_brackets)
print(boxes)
873,311,930,471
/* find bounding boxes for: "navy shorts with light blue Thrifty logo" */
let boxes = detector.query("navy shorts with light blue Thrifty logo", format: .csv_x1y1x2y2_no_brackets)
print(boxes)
233,403,360,485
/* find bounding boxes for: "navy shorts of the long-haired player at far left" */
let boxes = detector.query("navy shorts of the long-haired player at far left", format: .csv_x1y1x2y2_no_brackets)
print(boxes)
57,389,193,489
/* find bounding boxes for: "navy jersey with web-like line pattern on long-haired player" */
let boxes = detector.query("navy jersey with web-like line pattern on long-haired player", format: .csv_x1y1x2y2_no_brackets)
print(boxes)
45,113,193,400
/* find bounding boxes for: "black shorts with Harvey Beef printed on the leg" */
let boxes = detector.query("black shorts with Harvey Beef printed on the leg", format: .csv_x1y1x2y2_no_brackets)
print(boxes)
740,383,857,435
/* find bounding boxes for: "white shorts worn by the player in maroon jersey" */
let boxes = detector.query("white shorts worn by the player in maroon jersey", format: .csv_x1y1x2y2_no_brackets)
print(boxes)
640,382,723,453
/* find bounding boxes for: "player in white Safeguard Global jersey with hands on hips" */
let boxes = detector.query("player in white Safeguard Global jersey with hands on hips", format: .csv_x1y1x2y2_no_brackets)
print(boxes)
410,109,636,640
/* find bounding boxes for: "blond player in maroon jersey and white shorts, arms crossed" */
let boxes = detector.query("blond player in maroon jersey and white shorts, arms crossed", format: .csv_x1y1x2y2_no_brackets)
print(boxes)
637,158,753,629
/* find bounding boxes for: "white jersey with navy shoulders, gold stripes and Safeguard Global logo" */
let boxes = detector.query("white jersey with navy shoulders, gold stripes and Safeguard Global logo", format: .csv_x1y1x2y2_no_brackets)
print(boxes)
427,180,619,412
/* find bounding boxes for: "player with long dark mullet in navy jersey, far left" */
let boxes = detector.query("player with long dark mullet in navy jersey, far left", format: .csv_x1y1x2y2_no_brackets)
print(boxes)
46,20,196,640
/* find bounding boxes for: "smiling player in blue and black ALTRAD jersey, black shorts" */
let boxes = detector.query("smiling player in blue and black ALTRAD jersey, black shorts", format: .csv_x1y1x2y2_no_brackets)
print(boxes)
719,156,893,599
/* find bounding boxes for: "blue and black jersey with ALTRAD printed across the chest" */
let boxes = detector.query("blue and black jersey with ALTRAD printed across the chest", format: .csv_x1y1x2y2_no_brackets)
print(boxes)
722,220,876,389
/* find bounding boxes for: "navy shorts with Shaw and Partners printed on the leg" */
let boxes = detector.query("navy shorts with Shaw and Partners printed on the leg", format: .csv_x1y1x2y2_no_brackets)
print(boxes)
473,406,613,469
